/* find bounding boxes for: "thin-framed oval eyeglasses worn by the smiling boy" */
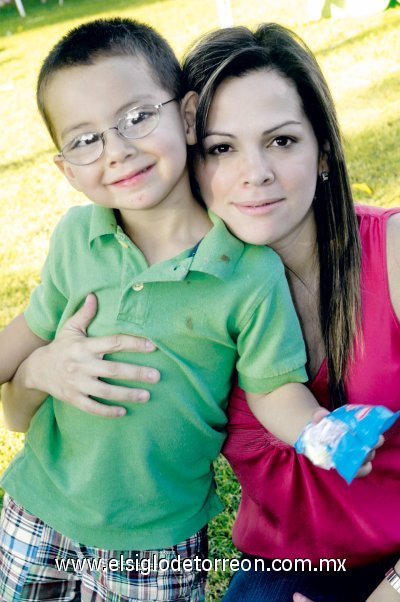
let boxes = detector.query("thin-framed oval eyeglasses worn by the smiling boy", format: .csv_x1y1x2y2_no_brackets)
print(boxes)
58,98,178,165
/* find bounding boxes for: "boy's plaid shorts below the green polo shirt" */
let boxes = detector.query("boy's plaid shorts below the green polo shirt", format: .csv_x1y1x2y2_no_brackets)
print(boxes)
0,494,208,602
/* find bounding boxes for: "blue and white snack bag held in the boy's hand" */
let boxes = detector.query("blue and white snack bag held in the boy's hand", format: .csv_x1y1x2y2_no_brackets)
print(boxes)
295,404,400,483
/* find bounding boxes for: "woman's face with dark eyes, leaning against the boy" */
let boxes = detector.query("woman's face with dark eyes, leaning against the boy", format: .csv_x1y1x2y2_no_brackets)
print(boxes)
196,70,320,252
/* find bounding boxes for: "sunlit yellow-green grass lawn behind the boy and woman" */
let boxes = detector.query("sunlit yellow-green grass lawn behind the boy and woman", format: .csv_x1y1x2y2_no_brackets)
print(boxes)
0,0,400,602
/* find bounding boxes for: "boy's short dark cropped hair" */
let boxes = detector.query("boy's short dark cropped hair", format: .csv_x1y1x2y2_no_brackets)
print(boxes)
36,18,183,146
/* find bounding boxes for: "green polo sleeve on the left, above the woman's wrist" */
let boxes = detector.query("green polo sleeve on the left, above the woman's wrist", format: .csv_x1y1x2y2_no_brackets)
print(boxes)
24,223,67,341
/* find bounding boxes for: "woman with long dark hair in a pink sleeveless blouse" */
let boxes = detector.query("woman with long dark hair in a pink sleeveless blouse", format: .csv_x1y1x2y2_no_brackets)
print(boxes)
6,24,400,602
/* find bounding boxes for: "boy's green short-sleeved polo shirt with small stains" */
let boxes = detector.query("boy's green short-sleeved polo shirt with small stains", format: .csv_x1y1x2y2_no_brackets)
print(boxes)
2,205,307,549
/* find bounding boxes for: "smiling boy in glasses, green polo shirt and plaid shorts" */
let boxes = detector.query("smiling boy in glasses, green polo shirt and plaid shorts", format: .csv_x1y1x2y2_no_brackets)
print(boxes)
0,19,319,602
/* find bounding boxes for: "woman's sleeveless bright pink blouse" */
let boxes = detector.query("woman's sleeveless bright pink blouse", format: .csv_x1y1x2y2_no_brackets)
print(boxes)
224,206,400,567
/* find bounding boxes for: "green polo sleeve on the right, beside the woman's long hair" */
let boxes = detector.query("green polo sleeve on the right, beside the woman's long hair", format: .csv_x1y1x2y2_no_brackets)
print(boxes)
236,270,308,393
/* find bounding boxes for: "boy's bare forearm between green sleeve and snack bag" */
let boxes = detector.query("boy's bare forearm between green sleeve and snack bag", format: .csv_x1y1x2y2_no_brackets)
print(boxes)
246,383,321,445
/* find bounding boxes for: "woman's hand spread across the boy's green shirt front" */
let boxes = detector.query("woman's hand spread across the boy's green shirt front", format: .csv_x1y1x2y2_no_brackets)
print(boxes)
26,294,160,418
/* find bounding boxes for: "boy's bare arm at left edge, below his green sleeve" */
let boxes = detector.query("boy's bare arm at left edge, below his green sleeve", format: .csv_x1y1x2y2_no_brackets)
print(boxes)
0,314,47,384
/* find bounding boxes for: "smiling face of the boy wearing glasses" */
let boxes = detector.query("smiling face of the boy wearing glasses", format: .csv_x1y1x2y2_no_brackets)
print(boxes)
45,56,190,218
